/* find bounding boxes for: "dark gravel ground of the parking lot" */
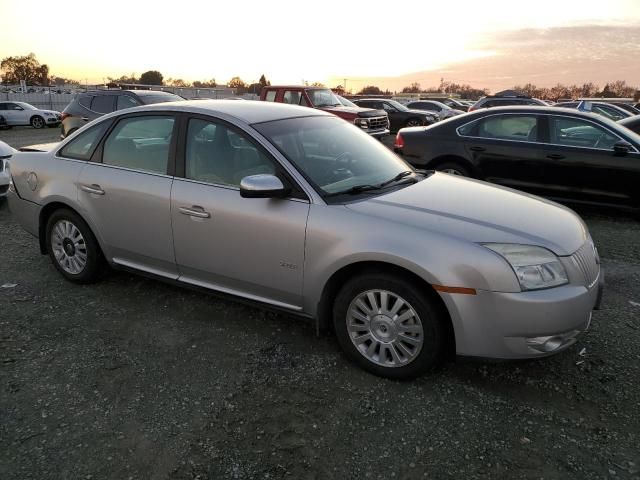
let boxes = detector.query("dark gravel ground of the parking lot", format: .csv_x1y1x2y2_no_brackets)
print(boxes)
0,129,640,480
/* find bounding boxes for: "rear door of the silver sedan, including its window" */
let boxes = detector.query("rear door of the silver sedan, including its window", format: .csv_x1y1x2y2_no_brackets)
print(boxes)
78,114,177,278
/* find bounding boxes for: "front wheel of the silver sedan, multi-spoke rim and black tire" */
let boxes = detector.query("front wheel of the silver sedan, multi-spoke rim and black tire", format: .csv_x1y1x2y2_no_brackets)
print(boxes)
333,272,447,379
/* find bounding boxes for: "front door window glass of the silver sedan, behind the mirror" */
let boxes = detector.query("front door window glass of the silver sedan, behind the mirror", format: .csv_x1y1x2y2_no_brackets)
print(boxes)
185,119,276,186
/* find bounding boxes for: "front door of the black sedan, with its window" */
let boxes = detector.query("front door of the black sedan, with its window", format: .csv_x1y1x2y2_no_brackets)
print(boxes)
544,115,640,207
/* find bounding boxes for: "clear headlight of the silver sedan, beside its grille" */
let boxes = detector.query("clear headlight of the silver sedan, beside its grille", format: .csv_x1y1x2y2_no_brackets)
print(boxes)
483,243,569,290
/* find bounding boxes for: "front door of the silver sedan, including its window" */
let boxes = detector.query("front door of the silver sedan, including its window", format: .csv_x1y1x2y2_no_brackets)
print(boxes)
171,118,309,310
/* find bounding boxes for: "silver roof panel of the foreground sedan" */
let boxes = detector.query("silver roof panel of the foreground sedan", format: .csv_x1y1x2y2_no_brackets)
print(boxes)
117,100,338,124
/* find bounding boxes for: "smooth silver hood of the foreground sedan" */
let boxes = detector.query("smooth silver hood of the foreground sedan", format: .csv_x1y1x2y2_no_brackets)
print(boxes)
347,172,587,256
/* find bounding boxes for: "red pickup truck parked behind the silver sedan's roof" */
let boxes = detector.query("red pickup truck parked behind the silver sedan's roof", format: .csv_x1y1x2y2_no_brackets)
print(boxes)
260,85,389,137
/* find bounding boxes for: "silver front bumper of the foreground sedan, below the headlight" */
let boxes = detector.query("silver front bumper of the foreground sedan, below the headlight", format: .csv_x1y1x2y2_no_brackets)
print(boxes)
440,271,604,359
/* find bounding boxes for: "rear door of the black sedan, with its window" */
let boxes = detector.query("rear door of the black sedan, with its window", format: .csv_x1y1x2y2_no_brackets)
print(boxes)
458,113,545,193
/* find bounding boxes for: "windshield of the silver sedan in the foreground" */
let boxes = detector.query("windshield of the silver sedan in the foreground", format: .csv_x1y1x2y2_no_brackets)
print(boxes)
254,116,413,201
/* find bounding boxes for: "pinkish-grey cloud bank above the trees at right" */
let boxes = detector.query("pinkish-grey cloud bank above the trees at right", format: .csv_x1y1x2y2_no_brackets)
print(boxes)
332,23,640,91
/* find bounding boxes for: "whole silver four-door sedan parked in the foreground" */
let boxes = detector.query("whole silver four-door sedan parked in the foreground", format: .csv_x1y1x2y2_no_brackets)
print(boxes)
9,101,603,378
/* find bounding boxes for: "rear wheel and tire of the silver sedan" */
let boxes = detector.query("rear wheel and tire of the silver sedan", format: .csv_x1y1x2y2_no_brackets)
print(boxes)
46,209,105,284
